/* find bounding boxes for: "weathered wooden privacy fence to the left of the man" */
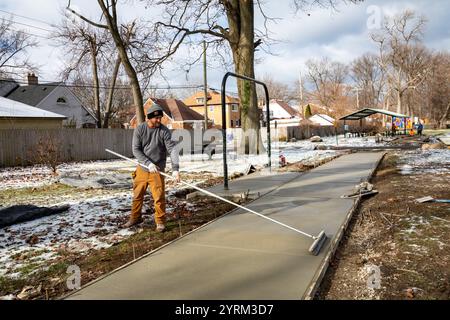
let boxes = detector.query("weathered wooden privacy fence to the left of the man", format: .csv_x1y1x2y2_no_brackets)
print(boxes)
0,129,133,167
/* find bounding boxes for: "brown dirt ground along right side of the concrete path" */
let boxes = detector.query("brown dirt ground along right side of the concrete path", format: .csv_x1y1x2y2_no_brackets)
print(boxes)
316,151,450,300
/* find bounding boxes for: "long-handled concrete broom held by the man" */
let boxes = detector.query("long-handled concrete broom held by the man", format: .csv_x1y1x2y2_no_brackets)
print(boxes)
105,149,327,256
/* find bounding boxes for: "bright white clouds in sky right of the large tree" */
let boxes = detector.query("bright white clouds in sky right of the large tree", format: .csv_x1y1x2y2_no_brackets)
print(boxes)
256,0,450,83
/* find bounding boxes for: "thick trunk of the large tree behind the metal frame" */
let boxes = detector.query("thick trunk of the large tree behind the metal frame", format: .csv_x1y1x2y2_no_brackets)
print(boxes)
230,0,265,154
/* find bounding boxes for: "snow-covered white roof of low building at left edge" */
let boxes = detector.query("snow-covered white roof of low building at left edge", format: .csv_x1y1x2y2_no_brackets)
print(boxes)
0,97,66,119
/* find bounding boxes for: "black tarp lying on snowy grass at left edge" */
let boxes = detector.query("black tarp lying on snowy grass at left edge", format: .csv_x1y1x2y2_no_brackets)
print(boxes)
0,205,70,228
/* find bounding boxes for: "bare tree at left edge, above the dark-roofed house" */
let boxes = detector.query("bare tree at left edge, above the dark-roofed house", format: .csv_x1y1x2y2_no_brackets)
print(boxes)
0,19,37,78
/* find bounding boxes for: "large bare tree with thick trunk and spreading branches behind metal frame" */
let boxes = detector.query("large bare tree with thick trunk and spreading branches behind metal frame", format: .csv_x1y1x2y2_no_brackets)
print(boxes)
147,0,356,153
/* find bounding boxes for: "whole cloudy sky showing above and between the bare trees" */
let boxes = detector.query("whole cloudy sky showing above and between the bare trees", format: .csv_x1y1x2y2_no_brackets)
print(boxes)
0,0,450,92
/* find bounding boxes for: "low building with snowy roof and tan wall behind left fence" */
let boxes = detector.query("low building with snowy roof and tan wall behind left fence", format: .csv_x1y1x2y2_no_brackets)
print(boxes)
0,97,66,129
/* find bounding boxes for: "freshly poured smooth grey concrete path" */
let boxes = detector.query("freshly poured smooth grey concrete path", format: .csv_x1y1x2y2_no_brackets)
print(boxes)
69,153,382,300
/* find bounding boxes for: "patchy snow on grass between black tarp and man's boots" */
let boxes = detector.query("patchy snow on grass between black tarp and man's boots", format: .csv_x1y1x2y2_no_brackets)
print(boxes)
0,191,133,276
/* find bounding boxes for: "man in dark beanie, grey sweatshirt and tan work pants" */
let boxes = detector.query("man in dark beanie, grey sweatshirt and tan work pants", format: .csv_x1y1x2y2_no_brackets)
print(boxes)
124,104,180,232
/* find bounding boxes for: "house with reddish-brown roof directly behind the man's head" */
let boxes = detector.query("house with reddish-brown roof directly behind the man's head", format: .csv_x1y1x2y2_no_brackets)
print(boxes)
130,98,204,129
